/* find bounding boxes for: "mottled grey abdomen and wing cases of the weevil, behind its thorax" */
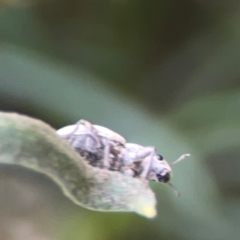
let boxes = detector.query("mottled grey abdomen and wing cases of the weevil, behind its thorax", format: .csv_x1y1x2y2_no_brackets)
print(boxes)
57,120,126,172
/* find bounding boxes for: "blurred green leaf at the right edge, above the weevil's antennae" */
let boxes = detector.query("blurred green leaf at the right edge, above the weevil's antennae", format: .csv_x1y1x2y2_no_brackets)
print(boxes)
169,89,240,153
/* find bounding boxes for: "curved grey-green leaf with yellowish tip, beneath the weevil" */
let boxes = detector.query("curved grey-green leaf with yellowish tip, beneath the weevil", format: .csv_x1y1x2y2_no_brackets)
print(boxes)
0,113,156,218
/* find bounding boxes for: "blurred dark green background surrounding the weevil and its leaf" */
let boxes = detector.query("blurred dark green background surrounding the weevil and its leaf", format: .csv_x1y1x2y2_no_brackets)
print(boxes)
0,0,240,240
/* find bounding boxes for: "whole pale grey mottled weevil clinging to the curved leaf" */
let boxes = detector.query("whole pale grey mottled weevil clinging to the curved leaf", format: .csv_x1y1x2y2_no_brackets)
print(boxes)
57,120,190,193
